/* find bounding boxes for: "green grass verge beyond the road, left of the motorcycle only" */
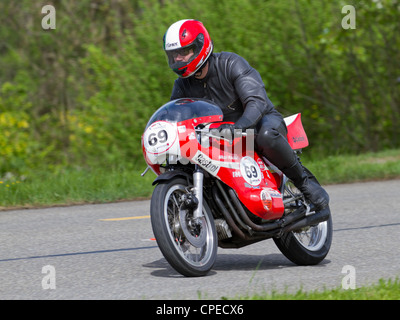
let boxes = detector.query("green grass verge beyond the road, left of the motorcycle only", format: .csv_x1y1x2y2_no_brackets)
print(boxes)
0,168,156,209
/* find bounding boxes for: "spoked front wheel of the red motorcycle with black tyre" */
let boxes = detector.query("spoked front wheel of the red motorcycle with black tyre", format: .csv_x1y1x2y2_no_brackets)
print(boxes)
150,177,217,277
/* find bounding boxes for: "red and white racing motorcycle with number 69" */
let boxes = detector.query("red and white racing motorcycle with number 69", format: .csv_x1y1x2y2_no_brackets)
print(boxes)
142,99,332,277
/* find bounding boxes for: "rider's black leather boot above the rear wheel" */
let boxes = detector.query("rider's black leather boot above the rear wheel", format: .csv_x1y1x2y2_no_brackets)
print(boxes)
282,161,329,211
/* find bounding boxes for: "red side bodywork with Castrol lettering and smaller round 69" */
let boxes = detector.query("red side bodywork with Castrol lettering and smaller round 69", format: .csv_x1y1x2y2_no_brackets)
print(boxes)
191,123,284,220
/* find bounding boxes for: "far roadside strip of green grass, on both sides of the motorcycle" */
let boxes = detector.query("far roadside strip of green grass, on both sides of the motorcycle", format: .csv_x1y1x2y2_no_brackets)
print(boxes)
0,150,400,209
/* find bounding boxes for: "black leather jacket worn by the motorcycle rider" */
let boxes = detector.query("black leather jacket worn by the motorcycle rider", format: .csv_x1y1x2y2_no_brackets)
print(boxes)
171,52,280,129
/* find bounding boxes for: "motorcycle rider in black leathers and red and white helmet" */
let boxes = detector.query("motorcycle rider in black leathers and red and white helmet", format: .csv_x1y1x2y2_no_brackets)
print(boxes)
163,19,329,210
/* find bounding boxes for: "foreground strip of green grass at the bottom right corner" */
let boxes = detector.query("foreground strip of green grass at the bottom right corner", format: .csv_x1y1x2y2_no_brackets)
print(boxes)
235,278,400,300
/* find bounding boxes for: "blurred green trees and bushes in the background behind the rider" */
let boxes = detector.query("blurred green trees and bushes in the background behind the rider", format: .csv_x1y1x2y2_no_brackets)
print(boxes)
0,0,400,176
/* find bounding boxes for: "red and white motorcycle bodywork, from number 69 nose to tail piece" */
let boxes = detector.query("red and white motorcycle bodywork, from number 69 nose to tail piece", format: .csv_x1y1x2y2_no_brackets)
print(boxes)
142,99,308,220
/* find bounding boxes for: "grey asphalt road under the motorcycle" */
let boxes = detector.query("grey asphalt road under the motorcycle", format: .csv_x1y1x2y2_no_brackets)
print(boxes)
0,180,400,300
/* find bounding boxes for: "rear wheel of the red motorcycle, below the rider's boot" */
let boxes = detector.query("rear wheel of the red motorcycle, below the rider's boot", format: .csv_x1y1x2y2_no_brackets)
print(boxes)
274,212,333,265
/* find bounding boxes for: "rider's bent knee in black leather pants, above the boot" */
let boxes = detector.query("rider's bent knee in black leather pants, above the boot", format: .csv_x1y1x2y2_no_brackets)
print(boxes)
255,113,297,171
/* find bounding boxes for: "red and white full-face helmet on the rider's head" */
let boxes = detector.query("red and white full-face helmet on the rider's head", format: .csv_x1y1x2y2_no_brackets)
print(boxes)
164,19,213,78
